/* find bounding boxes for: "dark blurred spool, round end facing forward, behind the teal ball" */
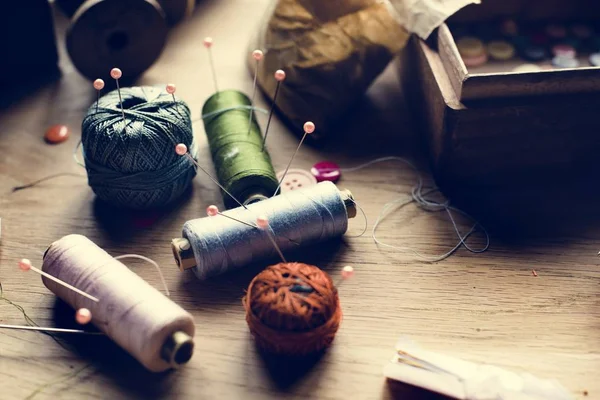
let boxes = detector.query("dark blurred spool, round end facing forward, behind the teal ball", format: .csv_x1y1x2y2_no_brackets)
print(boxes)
67,0,168,82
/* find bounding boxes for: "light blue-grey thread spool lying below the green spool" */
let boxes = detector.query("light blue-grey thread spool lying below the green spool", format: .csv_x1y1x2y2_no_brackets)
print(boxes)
171,182,356,279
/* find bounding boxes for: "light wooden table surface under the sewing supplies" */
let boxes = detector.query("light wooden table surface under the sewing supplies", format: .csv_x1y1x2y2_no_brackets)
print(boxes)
0,0,600,399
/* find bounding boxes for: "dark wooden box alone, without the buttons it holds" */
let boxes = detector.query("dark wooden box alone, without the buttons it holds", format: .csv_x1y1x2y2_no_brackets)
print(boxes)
401,0,600,188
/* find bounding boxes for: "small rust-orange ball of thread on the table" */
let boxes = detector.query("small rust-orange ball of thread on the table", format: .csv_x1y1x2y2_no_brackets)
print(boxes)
243,263,342,356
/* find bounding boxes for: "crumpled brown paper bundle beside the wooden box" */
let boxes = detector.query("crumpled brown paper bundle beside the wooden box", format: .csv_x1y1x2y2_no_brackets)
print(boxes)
248,0,479,137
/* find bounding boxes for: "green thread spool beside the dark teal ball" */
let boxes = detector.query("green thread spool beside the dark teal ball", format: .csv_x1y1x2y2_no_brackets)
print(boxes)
202,90,279,208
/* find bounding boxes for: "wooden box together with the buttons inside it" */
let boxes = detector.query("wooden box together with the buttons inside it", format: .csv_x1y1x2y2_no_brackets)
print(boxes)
401,0,600,188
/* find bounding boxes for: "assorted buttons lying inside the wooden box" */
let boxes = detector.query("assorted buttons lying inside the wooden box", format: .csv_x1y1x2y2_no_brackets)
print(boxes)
450,19,600,72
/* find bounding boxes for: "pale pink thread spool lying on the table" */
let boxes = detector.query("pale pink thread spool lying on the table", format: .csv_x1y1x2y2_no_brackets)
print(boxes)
42,235,195,372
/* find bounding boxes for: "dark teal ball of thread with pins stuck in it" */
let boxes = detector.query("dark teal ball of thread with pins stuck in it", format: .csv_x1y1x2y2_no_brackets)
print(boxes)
81,87,196,209
